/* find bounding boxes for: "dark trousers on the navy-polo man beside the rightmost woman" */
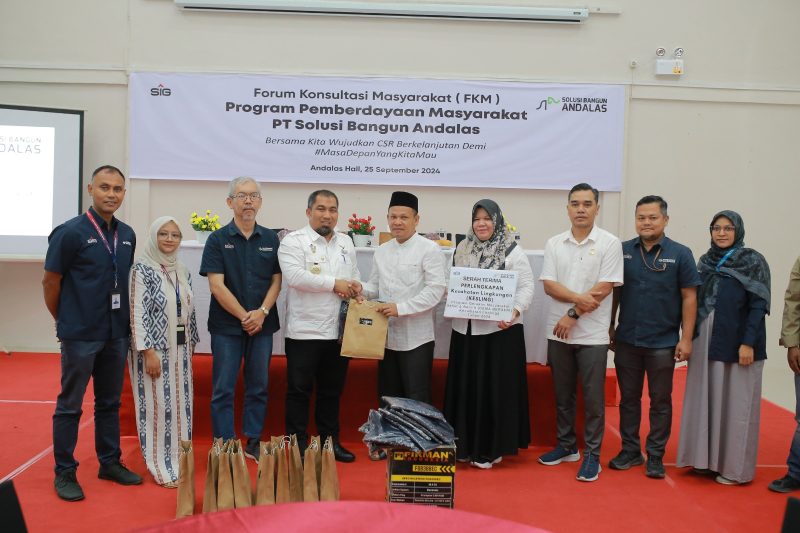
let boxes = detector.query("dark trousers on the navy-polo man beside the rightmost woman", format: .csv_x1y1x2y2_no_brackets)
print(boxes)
614,342,675,457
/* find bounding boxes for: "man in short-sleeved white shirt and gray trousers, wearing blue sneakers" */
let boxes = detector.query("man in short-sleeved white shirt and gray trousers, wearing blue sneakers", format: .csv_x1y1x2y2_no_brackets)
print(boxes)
539,183,624,481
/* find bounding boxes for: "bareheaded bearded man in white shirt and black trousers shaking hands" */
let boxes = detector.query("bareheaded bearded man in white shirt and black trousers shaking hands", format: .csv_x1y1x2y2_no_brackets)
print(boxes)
278,190,361,463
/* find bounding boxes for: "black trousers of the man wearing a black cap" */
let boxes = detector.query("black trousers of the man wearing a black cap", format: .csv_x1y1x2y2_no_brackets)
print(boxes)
378,341,434,405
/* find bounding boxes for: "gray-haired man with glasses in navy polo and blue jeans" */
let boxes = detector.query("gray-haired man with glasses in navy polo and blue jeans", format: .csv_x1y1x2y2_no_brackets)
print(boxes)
200,177,281,462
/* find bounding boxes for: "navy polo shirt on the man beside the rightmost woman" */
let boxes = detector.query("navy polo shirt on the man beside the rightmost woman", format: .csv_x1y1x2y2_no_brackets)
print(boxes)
616,236,702,348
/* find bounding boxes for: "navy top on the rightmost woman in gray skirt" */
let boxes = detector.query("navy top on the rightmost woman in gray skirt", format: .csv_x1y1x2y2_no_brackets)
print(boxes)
708,276,769,363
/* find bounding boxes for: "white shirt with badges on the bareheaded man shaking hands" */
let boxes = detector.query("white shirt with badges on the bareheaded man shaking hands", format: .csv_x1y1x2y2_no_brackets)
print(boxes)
278,226,361,340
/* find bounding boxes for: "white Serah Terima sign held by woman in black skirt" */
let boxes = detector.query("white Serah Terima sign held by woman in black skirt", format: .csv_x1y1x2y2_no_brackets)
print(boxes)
444,267,517,321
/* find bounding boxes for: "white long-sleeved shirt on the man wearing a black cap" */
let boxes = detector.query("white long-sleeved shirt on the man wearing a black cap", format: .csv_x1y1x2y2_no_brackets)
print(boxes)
363,234,446,351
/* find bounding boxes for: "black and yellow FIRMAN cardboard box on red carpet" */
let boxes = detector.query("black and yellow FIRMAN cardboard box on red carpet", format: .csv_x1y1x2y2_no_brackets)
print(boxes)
386,446,456,509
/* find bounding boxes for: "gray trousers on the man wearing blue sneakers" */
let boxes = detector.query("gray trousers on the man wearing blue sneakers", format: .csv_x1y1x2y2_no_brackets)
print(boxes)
547,340,608,455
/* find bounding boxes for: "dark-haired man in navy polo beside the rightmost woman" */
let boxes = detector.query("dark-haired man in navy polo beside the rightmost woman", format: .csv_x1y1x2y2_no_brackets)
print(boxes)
608,196,701,479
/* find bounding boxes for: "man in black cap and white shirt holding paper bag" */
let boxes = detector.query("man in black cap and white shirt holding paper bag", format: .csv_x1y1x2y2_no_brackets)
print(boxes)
363,191,446,416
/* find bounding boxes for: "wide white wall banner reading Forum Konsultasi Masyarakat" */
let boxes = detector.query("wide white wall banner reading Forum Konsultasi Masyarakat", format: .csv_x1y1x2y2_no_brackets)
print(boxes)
129,73,625,191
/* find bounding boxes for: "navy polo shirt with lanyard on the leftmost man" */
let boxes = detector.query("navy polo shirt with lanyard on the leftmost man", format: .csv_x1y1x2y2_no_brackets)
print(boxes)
44,207,136,341
